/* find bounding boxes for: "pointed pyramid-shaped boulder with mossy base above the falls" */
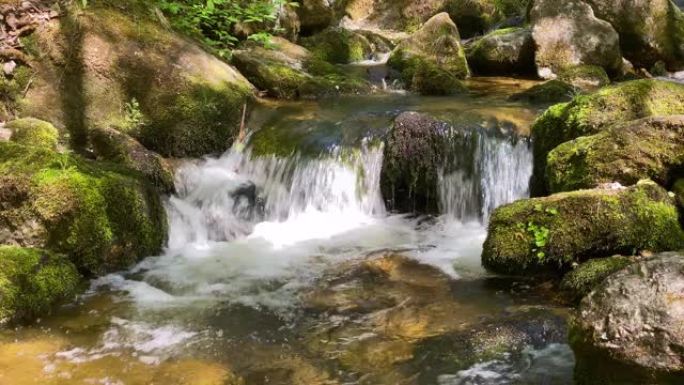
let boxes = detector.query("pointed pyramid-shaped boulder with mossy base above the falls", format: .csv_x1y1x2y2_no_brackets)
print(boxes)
388,13,470,95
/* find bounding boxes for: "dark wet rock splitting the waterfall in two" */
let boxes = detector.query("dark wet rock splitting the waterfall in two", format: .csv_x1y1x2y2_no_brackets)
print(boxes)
380,112,451,213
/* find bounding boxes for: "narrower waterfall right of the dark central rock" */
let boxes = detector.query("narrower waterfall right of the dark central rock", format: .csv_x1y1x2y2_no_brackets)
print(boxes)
438,130,532,223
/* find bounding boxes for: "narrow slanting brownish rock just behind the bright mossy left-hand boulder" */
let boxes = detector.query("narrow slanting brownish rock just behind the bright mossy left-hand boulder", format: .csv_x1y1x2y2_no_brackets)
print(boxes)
90,128,175,194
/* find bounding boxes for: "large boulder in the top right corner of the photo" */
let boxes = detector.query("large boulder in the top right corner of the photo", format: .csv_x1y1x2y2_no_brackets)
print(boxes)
586,0,684,70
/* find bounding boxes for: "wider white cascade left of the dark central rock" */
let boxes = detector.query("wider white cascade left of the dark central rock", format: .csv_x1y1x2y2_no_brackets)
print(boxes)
168,143,385,250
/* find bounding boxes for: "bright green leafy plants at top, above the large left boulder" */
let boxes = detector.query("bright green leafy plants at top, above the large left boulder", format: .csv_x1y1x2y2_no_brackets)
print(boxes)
157,0,297,56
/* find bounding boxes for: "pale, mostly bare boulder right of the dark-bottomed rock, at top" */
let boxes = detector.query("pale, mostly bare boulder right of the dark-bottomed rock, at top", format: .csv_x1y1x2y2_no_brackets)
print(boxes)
529,0,622,79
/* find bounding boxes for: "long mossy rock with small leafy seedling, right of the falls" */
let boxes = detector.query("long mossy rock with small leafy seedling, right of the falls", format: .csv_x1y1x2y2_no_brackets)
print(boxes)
482,181,684,274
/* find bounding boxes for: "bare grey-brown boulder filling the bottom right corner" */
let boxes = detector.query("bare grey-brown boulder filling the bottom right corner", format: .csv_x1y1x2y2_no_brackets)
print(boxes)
570,253,684,385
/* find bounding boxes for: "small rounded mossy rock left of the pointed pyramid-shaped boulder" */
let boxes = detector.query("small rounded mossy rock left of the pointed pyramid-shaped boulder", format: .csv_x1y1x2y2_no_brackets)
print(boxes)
300,28,373,64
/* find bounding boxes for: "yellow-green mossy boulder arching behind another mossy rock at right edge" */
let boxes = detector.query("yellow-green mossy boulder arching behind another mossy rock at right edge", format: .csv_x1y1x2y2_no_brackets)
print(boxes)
531,79,684,196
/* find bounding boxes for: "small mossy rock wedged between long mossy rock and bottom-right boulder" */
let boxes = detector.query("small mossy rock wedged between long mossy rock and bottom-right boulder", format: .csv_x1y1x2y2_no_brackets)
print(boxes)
560,255,634,303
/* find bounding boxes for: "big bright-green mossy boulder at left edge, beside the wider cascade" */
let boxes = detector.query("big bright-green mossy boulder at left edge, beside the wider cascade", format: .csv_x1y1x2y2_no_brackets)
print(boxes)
0,142,167,275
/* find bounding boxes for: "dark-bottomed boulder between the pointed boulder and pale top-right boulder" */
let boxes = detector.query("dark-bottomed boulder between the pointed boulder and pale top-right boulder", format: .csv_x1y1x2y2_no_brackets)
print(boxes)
466,28,536,75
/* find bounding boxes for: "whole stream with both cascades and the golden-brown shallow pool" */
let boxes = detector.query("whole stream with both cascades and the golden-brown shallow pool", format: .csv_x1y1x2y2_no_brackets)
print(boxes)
0,79,573,385
